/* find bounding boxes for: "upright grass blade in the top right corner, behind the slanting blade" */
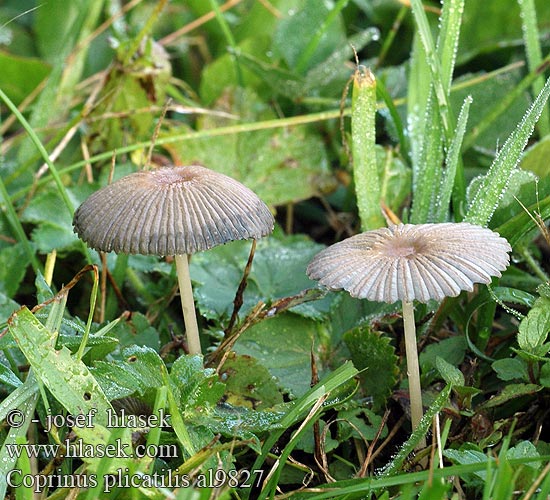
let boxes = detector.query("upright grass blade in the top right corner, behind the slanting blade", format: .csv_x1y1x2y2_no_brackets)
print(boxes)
518,0,550,137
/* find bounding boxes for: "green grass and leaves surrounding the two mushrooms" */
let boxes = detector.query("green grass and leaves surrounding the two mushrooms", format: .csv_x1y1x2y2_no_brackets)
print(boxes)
0,0,550,500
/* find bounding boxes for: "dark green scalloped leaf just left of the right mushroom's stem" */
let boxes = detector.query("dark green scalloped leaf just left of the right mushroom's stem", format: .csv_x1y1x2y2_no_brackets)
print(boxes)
344,327,399,410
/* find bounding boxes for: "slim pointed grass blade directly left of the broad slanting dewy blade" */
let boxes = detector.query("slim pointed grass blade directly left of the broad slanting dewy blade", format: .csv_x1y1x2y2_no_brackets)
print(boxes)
434,96,472,222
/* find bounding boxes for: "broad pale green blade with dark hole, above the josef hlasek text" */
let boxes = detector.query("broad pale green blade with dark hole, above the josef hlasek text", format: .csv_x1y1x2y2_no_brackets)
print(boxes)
8,307,112,424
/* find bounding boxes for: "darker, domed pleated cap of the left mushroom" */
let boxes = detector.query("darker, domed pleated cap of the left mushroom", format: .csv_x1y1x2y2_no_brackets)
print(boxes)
73,165,274,255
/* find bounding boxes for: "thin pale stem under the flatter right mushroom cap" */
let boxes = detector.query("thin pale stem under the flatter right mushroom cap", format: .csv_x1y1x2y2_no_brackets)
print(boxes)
402,300,426,448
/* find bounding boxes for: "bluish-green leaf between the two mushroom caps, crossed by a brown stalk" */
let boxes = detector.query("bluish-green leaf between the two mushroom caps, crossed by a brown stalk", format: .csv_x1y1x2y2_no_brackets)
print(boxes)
190,237,334,320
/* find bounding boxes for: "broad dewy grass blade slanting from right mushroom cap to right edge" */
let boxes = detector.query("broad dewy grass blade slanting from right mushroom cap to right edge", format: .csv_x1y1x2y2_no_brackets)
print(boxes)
466,79,550,226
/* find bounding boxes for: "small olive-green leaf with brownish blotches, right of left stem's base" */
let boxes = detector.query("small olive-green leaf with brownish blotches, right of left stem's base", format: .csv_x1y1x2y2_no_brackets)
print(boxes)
218,353,283,410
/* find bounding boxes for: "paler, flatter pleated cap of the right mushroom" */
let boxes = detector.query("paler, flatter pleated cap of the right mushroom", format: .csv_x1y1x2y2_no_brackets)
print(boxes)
307,222,512,303
